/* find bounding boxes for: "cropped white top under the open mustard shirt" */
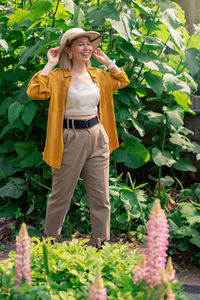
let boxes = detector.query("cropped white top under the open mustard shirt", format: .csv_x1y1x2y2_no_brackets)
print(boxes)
65,82,100,116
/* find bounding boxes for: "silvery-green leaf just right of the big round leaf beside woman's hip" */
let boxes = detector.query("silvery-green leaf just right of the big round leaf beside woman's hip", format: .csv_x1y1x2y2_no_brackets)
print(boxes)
152,148,175,167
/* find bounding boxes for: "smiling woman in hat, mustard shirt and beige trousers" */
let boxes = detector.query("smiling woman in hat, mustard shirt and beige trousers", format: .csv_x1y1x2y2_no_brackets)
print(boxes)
27,28,129,243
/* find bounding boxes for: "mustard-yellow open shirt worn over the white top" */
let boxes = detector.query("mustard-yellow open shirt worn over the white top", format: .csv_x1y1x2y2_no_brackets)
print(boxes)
27,67,129,169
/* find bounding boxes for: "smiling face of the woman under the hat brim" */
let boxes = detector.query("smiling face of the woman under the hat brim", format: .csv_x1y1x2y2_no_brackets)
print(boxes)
68,36,93,63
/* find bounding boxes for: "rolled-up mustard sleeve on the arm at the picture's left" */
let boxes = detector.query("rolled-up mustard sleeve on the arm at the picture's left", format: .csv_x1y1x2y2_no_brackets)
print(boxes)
26,72,51,100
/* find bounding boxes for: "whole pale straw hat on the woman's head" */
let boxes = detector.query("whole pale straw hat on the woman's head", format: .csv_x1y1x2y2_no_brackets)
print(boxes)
59,28,101,53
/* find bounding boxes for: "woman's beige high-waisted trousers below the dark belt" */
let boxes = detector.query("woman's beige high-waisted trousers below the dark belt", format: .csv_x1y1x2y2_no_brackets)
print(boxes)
45,123,110,240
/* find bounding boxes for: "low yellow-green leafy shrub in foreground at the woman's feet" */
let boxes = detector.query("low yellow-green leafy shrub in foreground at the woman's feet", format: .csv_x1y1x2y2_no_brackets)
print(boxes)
0,239,187,300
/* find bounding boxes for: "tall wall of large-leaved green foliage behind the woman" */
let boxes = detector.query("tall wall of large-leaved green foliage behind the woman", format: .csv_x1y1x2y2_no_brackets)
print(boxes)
0,0,200,258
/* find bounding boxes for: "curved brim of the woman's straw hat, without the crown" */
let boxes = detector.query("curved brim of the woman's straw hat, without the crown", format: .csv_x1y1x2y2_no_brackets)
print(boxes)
59,31,101,53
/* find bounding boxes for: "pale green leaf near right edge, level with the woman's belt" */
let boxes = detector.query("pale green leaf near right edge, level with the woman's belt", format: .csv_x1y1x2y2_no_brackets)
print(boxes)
163,106,184,130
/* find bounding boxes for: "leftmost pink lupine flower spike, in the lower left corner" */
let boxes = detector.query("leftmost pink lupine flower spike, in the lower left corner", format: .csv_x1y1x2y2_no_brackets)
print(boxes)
15,223,31,287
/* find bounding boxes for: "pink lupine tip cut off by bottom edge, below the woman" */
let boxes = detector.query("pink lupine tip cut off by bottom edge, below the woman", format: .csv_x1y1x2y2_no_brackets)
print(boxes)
88,268,107,300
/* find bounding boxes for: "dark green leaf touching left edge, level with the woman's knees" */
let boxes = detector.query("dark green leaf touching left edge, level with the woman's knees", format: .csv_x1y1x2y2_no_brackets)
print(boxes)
0,178,26,199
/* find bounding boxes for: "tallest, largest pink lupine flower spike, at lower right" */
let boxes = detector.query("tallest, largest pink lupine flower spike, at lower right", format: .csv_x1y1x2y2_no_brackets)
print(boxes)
145,199,169,287
